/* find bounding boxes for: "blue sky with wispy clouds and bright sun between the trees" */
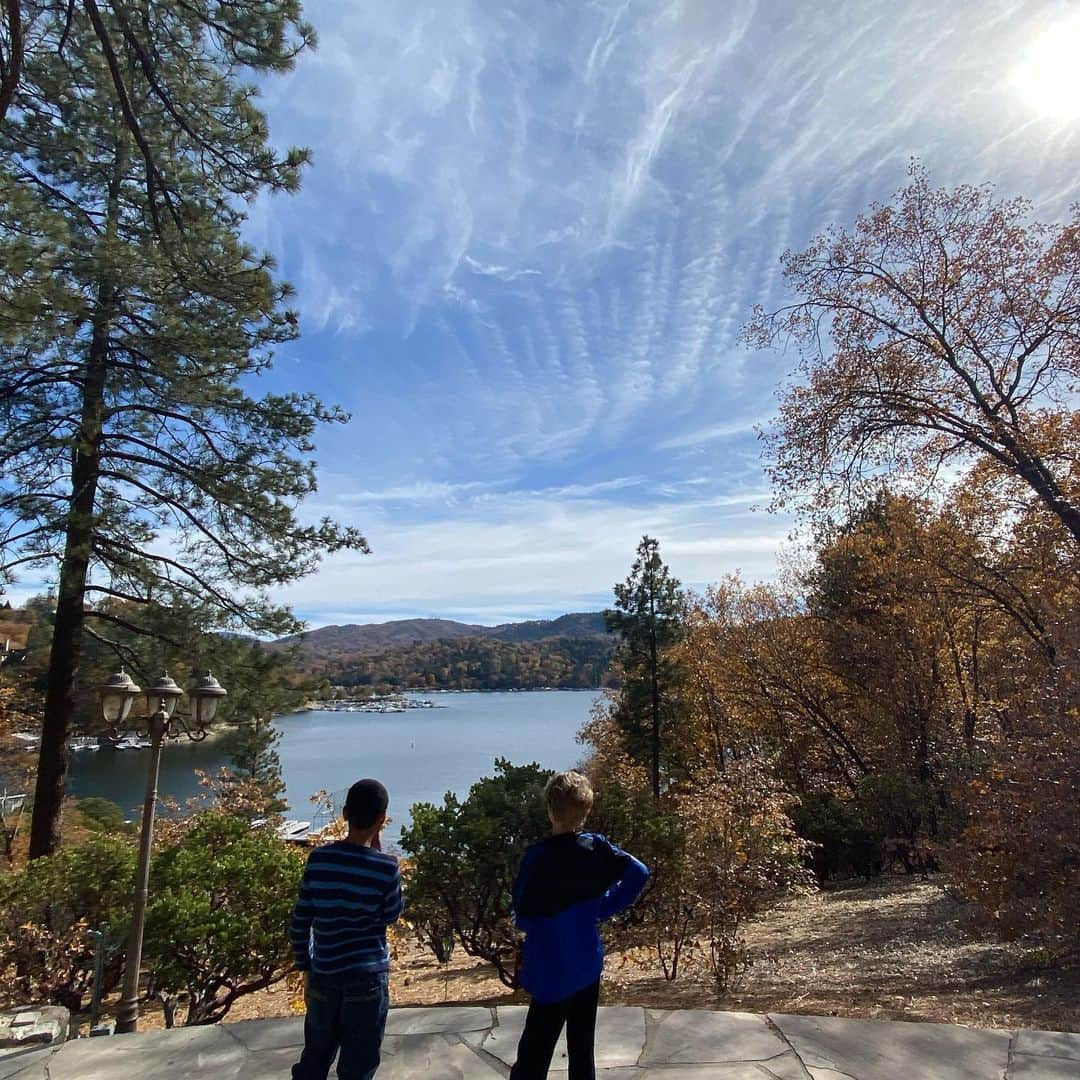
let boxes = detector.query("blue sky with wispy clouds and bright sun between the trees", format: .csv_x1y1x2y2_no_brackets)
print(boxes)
238,0,1080,626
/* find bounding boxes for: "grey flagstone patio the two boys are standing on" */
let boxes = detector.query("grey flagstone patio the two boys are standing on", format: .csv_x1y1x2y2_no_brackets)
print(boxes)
0,1005,1080,1080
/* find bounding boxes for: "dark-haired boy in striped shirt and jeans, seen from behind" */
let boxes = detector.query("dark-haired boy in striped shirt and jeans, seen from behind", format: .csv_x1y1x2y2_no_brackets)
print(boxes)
292,780,403,1080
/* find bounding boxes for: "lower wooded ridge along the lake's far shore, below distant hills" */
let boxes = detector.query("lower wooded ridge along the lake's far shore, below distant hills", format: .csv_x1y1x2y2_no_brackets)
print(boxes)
306,637,615,692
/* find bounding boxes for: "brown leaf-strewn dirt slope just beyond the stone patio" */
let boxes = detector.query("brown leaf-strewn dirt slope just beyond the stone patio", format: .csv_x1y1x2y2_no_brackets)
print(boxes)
128,878,1080,1031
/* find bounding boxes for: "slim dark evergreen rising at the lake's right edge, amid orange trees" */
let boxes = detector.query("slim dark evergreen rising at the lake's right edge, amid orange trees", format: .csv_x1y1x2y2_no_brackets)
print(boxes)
604,536,686,798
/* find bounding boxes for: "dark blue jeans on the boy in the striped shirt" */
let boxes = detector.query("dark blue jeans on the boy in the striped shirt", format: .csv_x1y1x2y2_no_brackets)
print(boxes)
293,971,390,1080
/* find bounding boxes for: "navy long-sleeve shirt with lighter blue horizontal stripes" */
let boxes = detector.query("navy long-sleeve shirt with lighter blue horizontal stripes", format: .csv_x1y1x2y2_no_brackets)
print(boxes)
292,840,404,975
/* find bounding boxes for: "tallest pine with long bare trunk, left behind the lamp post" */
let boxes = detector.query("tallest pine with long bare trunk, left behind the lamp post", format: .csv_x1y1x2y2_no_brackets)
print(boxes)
0,0,366,856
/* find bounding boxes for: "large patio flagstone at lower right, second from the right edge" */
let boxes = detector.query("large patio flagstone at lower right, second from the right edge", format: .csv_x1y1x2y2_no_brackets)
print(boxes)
769,1014,1012,1080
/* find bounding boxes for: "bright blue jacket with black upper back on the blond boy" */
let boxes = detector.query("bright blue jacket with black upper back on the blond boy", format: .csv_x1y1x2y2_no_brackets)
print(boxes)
514,833,649,1002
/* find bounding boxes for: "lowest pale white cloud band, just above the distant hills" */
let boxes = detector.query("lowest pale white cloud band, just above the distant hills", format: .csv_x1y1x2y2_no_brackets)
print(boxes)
286,485,791,625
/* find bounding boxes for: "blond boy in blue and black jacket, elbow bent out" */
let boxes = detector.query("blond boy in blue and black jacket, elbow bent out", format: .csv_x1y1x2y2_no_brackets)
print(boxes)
510,772,649,1080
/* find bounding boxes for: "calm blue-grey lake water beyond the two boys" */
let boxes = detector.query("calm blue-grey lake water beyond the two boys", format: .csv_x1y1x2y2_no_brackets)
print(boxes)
68,690,599,841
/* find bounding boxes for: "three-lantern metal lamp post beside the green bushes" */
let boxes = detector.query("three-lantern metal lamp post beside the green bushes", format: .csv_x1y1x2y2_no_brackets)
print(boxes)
100,671,227,1034
